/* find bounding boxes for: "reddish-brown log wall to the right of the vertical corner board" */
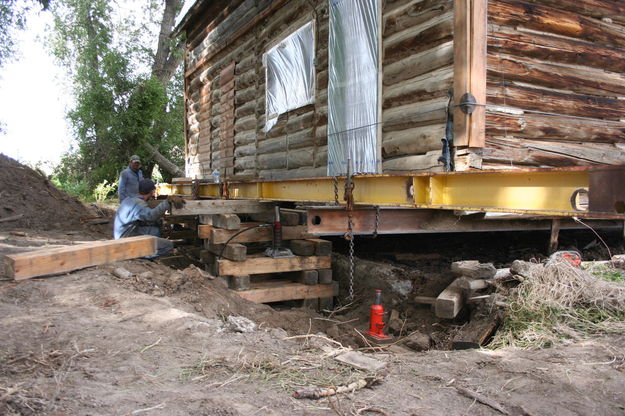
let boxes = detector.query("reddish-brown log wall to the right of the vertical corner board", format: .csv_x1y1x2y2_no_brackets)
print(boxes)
483,0,625,169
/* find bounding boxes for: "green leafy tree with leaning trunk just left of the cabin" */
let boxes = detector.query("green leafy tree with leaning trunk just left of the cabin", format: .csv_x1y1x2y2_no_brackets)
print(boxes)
51,0,184,192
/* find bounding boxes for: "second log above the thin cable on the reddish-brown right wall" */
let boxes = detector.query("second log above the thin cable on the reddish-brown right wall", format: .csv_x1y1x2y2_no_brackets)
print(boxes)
487,54,625,97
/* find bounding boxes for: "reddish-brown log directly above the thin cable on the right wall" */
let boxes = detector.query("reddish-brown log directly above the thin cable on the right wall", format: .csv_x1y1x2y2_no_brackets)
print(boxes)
486,82,625,120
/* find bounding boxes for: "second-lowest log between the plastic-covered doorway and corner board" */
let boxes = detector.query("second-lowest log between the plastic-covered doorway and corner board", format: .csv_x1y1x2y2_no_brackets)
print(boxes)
382,124,445,159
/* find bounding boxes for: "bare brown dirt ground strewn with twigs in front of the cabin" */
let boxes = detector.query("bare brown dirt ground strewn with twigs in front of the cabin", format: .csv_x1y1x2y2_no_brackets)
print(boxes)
0,157,625,416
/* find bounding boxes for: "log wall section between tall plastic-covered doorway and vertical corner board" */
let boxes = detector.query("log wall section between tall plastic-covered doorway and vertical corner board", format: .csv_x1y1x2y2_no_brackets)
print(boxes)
382,0,454,173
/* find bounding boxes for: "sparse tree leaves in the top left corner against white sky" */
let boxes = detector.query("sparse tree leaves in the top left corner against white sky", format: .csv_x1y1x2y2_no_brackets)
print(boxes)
0,0,50,68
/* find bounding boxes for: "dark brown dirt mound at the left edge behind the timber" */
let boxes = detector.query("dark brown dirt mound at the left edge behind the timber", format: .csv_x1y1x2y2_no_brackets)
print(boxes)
0,154,94,230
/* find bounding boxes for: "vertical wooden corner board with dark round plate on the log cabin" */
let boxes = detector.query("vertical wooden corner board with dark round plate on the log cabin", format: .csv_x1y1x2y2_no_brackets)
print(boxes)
453,0,487,148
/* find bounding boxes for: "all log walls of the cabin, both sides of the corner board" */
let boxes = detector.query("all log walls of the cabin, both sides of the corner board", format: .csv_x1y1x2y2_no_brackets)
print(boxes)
185,0,625,179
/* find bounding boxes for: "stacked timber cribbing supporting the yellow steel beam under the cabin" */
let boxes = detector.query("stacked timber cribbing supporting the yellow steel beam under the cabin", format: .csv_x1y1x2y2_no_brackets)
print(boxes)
198,209,338,308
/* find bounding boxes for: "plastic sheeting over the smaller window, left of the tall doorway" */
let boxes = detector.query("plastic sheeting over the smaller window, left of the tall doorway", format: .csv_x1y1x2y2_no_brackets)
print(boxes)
263,21,315,132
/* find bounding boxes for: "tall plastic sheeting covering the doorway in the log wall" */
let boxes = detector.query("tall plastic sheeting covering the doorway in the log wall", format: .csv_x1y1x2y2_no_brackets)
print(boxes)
328,0,380,176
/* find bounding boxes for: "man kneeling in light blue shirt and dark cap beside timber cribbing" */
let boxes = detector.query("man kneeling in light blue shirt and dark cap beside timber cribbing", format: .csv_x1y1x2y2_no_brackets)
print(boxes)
113,179,185,257
